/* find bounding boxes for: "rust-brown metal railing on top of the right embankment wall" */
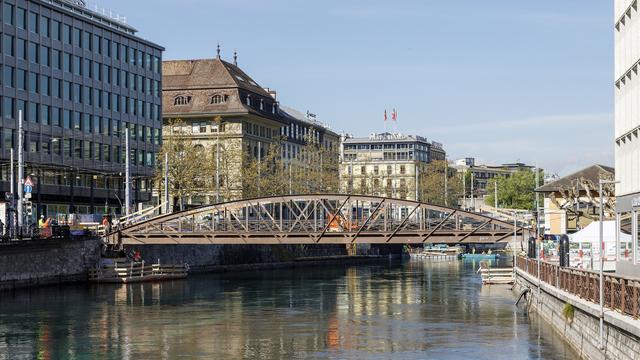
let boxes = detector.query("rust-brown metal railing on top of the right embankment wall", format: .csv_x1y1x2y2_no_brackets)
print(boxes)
516,257,640,318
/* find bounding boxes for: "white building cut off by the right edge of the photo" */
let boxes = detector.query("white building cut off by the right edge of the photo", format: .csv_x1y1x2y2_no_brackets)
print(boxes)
614,0,640,270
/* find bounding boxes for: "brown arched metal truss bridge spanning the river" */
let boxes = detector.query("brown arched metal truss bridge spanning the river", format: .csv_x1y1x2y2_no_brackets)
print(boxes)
107,194,528,245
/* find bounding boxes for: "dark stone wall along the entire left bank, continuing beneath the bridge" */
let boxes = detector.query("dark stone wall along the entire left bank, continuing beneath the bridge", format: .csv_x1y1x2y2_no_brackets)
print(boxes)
0,239,390,291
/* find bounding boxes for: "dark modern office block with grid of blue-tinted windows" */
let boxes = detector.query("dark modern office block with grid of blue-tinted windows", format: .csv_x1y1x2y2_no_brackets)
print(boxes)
0,0,164,216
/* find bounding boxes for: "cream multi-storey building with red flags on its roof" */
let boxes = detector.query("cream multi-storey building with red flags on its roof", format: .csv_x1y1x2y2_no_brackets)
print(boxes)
340,133,446,200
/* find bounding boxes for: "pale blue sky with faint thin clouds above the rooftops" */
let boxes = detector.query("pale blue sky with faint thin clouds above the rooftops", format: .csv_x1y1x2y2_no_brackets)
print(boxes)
112,0,613,175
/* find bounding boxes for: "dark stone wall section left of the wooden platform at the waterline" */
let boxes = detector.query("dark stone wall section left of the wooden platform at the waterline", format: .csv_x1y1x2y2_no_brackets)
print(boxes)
0,239,100,290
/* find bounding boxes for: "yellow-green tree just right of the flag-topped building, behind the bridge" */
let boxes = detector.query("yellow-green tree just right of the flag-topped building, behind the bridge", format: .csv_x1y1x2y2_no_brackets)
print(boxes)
418,160,462,207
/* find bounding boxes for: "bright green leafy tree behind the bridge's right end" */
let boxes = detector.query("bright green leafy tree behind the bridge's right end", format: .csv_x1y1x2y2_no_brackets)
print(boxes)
485,170,544,210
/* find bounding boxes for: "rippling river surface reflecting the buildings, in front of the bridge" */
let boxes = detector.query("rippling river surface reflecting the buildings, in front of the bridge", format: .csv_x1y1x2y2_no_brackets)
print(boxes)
0,261,575,359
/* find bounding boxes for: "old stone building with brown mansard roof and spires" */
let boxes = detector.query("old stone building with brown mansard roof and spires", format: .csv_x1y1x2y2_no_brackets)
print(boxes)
162,53,339,205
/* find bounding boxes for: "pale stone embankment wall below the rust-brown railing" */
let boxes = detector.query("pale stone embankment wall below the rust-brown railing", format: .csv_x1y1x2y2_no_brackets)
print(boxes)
514,270,640,360
